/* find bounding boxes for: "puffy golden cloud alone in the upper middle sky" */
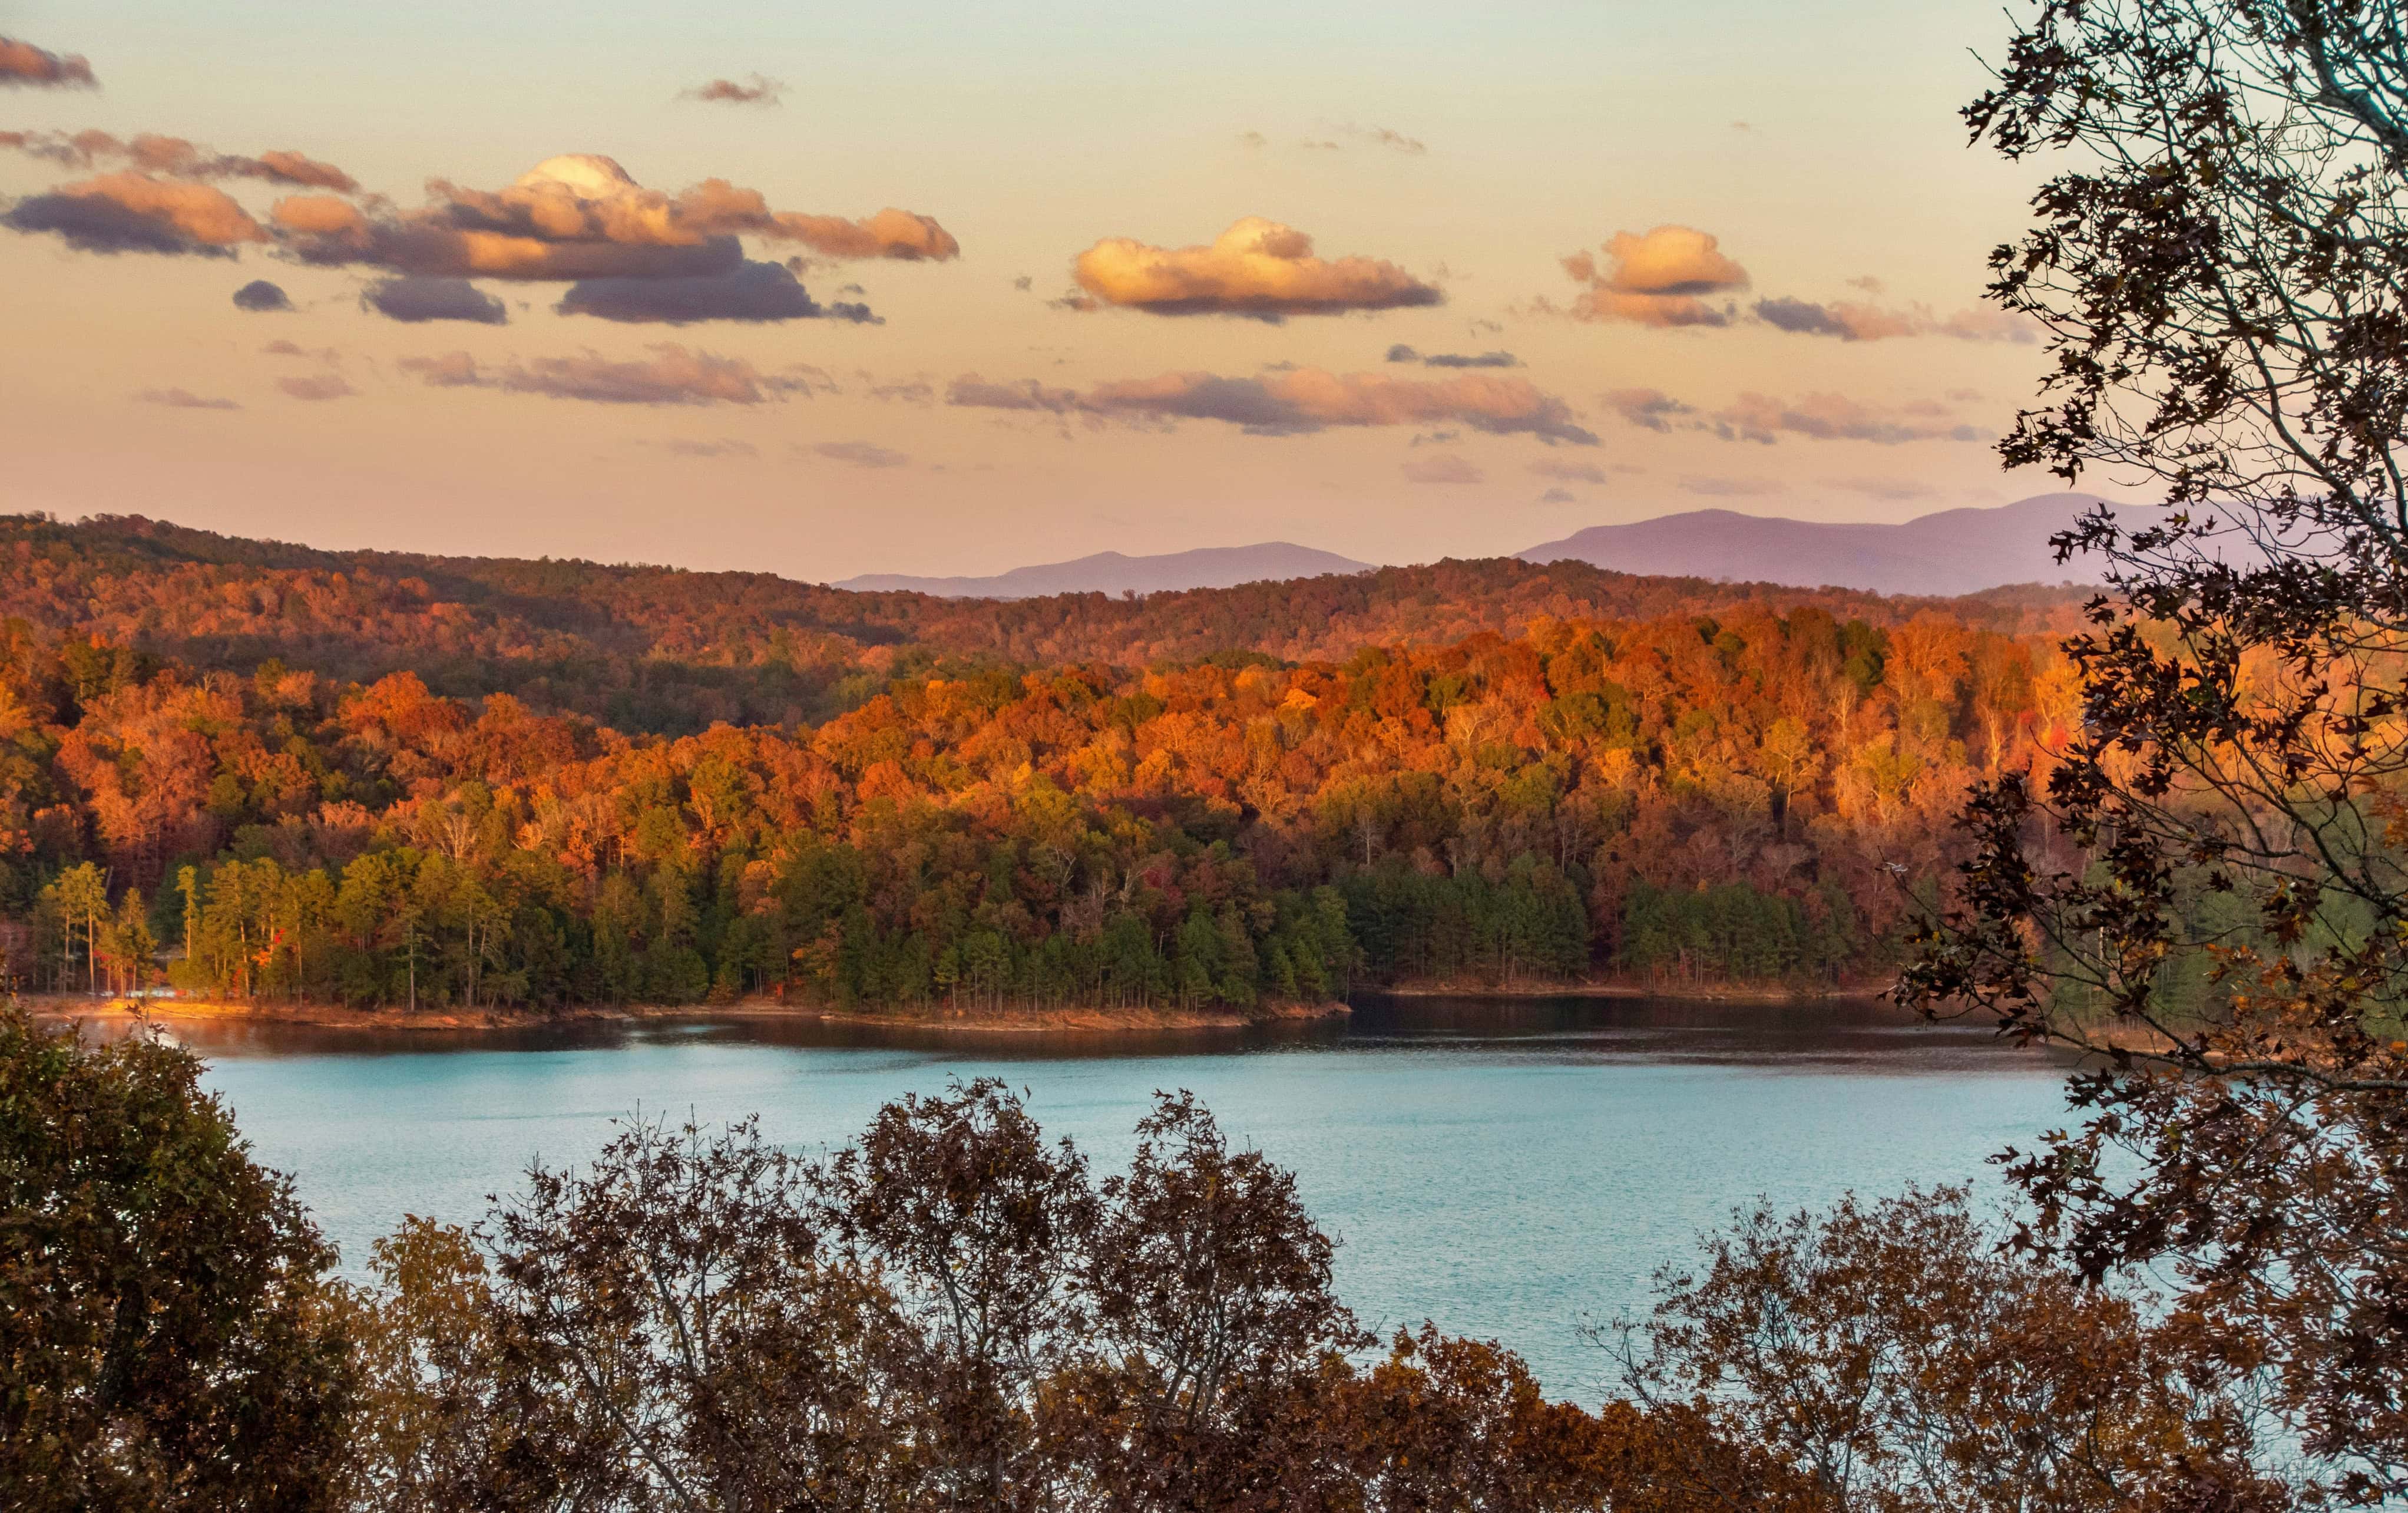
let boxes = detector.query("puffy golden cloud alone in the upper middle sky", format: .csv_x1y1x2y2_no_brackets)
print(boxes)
1071,217,1445,321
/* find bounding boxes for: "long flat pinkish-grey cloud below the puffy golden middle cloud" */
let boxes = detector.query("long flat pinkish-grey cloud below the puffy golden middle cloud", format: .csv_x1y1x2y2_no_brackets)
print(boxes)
947,369,1596,445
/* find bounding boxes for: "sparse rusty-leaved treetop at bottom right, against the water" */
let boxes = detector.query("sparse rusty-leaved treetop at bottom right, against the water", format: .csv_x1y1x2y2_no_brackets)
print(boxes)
1606,1188,2293,1513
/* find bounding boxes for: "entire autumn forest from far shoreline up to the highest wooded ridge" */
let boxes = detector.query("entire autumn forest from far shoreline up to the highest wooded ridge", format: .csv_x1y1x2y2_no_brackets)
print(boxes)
0,520,2076,1012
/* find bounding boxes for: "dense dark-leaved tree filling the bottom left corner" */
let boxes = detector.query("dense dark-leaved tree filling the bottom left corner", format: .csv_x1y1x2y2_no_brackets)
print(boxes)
0,1005,352,1513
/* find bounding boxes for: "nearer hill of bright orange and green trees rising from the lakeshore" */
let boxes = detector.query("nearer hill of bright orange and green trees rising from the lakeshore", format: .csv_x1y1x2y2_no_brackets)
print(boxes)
0,585,2078,1012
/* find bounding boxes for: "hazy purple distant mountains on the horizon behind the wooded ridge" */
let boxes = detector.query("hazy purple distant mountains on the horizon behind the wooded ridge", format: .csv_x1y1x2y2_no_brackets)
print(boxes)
833,494,2098,600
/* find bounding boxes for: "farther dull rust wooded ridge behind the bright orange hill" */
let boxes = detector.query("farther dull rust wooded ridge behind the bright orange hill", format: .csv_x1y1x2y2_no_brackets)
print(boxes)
0,516,2080,735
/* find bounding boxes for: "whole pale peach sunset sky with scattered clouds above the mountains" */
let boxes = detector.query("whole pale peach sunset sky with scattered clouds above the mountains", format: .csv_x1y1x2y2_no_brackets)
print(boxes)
0,0,2049,580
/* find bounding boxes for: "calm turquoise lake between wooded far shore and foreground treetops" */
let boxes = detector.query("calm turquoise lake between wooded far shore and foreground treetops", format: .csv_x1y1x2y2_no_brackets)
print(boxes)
155,1000,2063,1398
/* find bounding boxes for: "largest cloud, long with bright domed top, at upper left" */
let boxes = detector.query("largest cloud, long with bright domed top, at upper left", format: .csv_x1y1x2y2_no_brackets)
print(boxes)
272,154,961,279
